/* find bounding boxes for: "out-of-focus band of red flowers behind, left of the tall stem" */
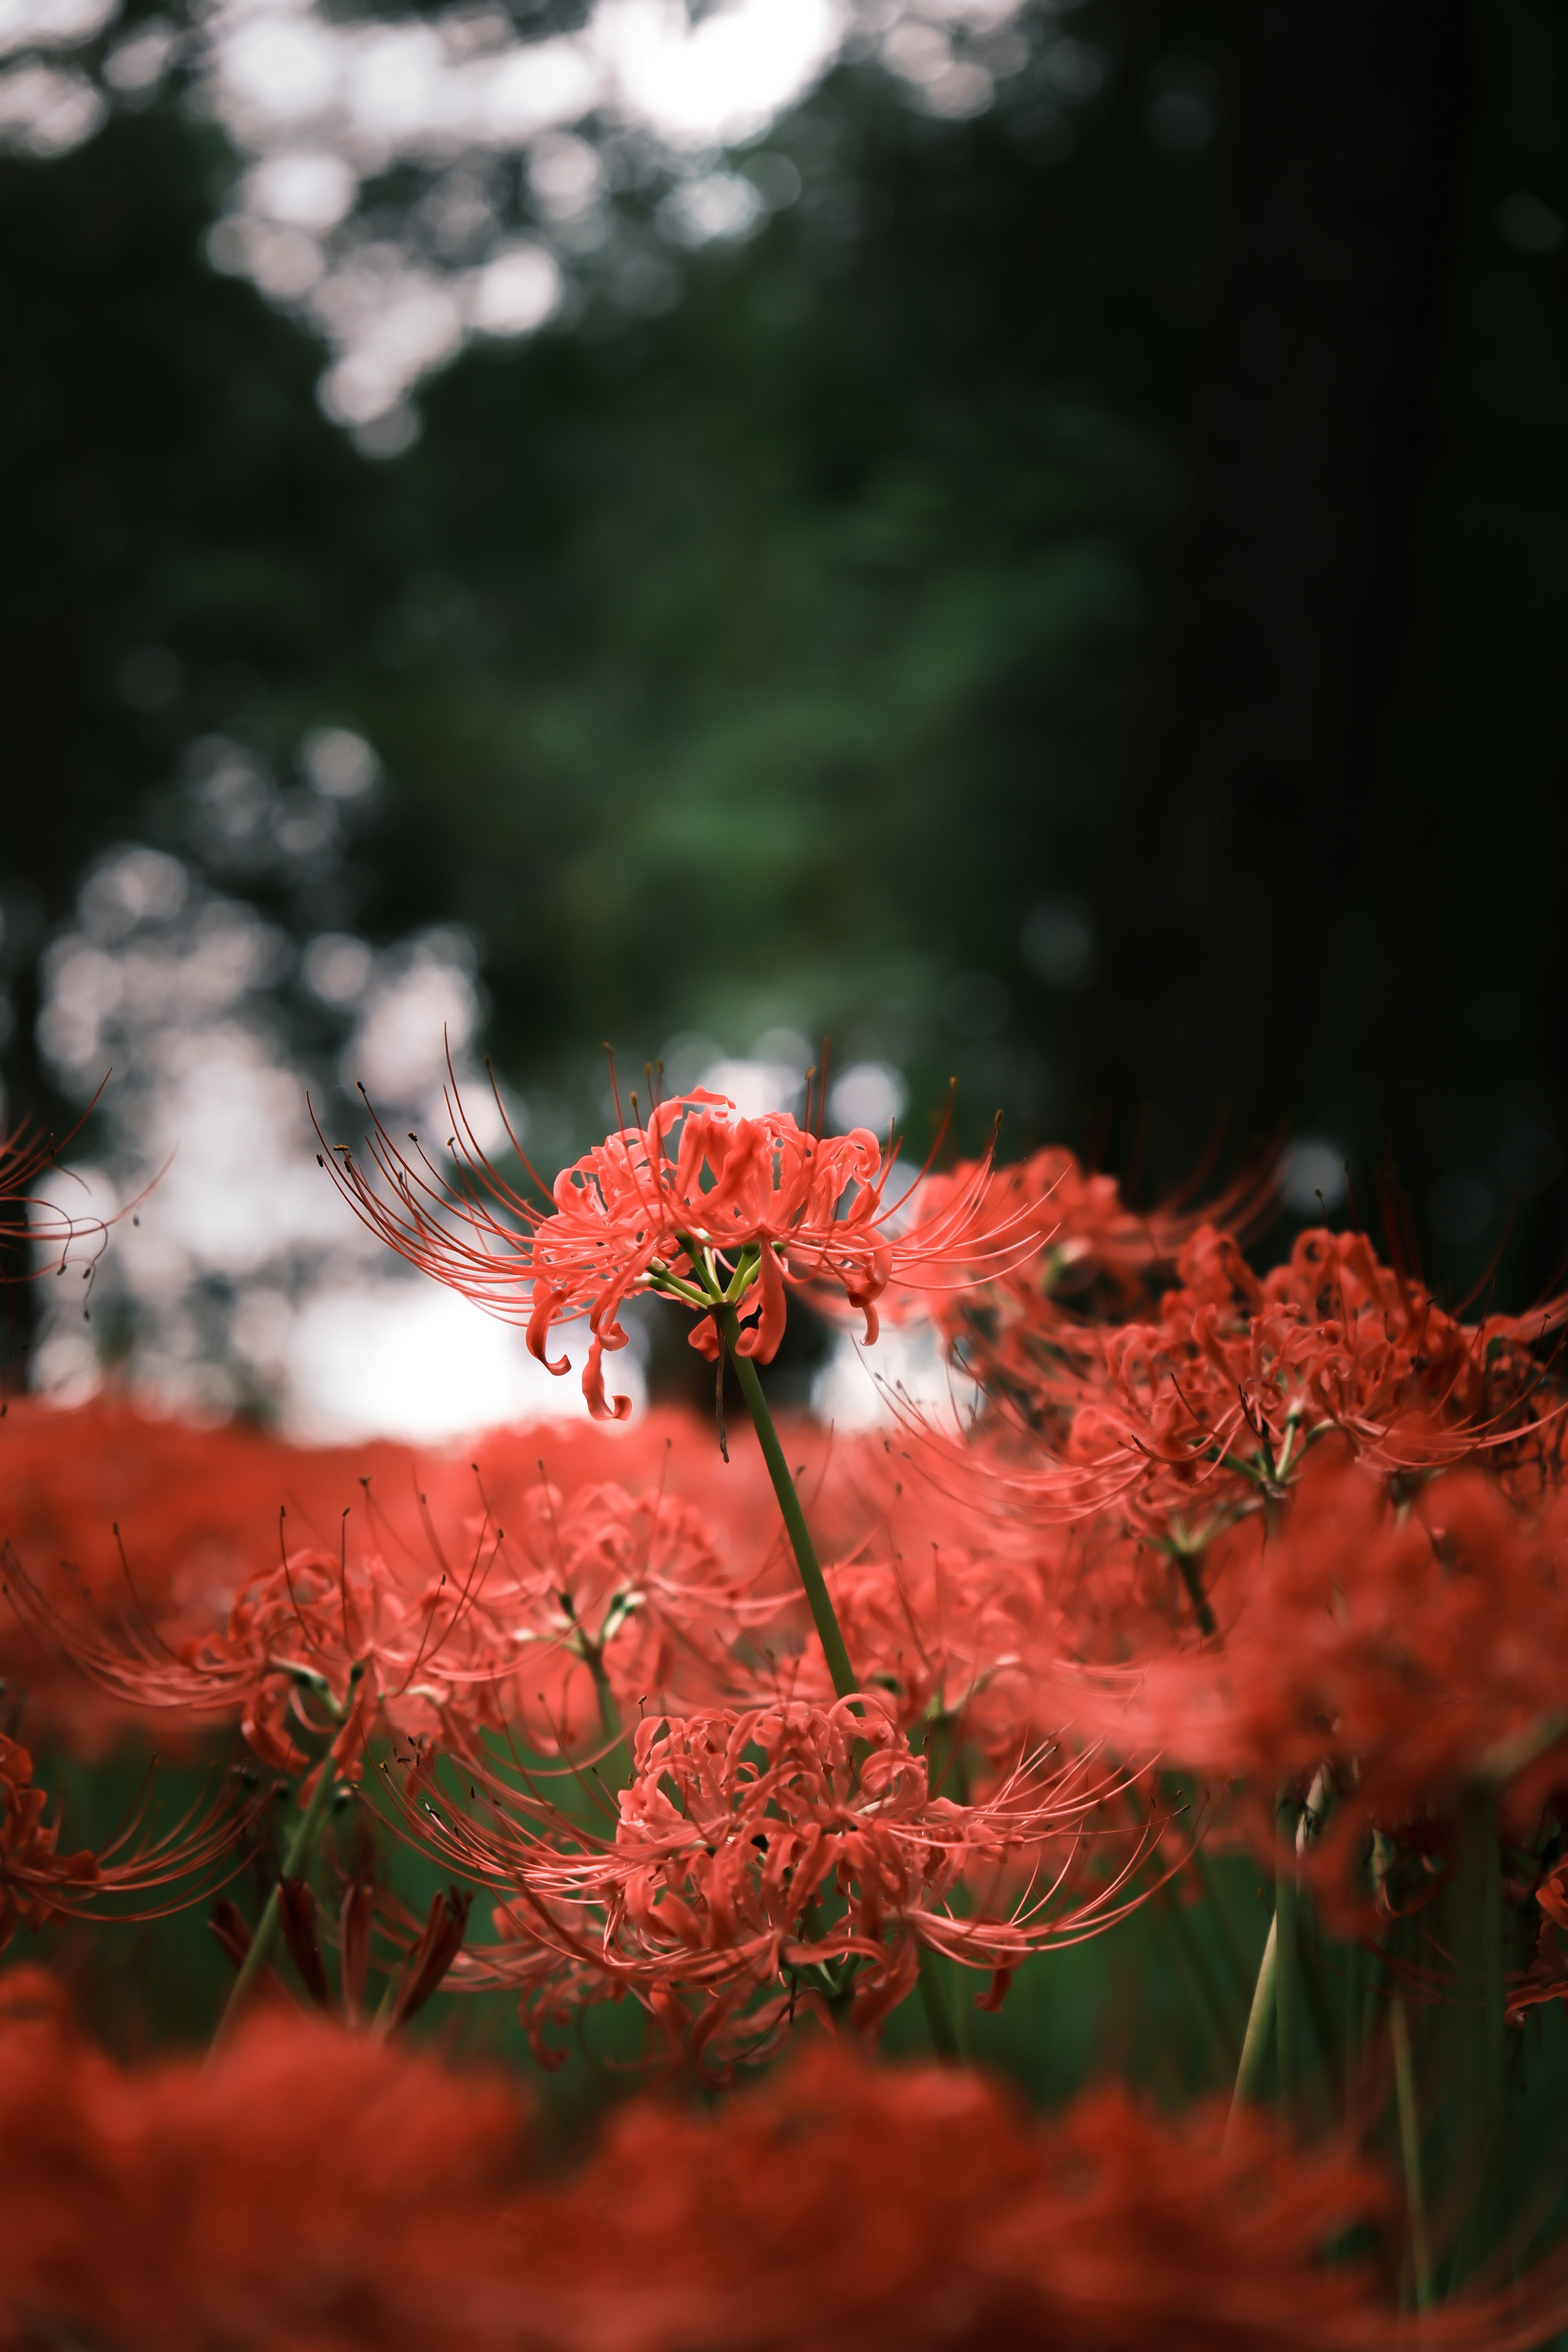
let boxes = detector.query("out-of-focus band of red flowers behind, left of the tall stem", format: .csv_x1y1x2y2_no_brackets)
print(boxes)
0,1395,822,1755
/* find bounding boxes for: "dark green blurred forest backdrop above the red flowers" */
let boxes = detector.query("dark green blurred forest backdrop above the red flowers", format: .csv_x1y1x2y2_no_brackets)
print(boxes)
0,0,1568,1364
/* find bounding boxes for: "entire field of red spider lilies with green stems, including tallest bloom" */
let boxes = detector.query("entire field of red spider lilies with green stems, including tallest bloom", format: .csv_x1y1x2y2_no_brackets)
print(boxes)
0,1091,1568,2352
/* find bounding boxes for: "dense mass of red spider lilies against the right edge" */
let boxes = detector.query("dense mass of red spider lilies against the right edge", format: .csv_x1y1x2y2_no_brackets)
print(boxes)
884,1155,1568,1922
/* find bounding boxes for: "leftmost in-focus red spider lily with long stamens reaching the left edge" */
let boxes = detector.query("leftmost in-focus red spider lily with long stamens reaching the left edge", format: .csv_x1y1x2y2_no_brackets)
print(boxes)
5,1545,510,1773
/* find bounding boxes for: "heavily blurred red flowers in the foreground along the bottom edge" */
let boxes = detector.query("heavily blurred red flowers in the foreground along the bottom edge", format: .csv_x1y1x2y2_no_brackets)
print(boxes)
0,1969,1566,2352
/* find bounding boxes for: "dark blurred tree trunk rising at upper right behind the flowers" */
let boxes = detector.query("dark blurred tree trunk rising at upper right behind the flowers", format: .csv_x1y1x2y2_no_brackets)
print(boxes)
1096,0,1474,1178
